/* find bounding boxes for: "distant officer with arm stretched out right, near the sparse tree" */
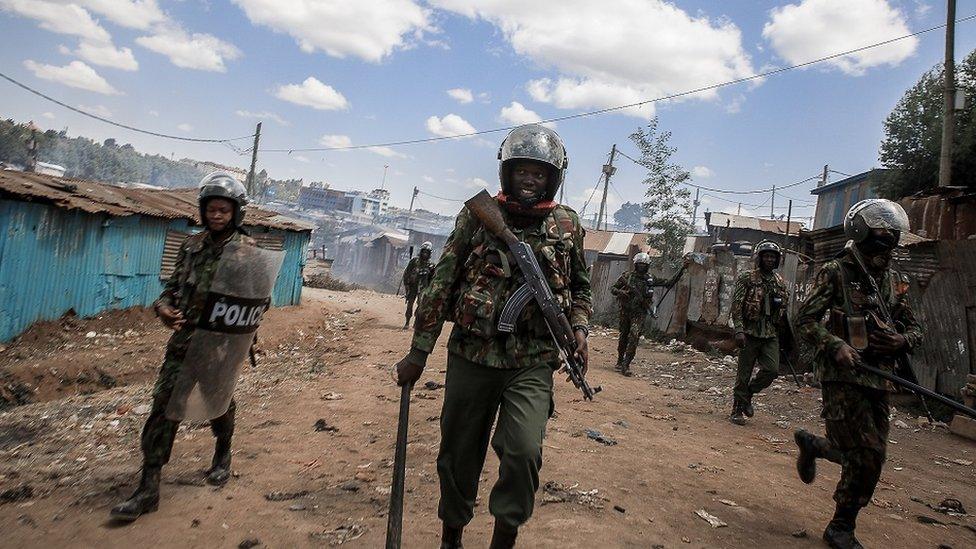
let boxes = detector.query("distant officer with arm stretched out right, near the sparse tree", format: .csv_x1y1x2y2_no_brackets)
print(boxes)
610,252,681,376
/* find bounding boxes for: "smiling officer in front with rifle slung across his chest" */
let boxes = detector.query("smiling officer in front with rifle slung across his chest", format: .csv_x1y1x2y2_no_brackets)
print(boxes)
396,124,591,549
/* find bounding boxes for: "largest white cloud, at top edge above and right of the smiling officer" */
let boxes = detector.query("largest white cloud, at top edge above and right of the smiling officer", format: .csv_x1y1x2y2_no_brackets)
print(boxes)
431,0,753,118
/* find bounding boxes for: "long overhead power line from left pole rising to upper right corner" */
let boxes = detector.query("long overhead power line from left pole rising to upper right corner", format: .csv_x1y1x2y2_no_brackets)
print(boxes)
255,14,976,153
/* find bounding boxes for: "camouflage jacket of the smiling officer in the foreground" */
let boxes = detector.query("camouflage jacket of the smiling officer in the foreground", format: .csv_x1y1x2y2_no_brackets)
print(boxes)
412,201,591,368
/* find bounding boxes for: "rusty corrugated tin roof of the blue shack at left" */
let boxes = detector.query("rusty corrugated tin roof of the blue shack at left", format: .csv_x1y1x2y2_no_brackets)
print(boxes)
0,170,315,231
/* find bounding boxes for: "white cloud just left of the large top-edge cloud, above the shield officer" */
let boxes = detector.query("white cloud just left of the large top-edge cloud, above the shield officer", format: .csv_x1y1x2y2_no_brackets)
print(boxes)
136,25,241,72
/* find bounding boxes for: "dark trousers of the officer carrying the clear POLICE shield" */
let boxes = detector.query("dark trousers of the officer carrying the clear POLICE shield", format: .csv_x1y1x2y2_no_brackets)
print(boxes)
141,347,237,467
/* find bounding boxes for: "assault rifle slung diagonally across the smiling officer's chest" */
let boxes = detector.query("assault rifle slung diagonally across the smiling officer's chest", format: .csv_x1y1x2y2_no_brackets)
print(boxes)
464,190,602,400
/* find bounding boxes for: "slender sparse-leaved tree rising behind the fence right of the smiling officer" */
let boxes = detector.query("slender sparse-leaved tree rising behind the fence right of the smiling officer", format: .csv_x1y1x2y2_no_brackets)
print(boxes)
630,117,694,265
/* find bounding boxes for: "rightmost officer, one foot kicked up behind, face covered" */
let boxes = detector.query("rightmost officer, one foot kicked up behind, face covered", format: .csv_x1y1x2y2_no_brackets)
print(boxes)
794,199,922,549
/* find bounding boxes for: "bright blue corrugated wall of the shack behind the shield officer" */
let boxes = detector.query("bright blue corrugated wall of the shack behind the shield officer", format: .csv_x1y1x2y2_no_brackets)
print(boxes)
0,200,309,341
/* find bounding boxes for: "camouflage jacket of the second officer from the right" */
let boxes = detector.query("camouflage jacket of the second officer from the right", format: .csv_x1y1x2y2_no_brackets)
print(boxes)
731,268,788,338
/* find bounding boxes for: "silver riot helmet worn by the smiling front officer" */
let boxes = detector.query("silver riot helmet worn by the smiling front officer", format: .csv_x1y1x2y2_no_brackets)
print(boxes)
498,124,569,200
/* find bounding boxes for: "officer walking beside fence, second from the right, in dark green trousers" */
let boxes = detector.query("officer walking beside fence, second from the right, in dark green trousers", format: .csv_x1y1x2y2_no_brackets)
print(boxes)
729,240,787,425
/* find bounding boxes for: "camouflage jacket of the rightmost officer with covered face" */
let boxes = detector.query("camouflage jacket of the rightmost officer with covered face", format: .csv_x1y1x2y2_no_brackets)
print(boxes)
795,254,922,389
